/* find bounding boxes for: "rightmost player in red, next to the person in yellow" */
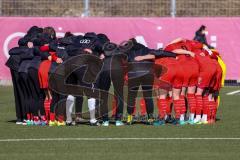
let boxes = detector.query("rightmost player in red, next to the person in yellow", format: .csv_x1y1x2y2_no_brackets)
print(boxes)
188,41,220,124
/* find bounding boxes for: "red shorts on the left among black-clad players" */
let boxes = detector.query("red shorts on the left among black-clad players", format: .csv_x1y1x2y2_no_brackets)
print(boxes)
38,60,52,89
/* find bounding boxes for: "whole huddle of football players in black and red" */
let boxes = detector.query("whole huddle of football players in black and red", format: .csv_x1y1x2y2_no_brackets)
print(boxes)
6,26,223,126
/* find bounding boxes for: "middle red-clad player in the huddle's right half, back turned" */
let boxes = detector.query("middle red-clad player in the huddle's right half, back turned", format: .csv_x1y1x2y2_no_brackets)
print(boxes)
165,38,199,125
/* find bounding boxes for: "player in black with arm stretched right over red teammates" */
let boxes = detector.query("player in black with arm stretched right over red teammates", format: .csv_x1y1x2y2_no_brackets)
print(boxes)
127,38,176,125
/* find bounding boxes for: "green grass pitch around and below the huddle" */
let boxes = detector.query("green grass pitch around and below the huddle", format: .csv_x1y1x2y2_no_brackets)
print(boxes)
0,87,240,160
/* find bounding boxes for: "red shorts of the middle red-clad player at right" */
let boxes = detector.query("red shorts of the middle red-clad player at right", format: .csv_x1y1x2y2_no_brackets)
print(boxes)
179,57,199,87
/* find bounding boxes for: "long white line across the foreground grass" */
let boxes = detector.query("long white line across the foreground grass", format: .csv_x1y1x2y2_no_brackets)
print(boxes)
0,138,240,142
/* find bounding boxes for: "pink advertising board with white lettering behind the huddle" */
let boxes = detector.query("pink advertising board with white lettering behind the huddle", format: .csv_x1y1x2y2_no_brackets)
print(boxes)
0,17,240,80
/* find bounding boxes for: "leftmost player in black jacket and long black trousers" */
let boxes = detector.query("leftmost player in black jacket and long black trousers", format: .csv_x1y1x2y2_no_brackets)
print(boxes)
6,26,42,124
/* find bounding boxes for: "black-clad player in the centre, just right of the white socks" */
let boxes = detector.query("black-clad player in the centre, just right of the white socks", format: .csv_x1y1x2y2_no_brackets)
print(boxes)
97,39,127,126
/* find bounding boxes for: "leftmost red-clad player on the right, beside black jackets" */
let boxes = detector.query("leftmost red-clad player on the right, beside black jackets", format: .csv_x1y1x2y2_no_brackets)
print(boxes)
154,45,194,125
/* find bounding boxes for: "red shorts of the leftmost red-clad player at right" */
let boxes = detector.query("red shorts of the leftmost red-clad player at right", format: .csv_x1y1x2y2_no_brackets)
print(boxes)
155,58,183,89
